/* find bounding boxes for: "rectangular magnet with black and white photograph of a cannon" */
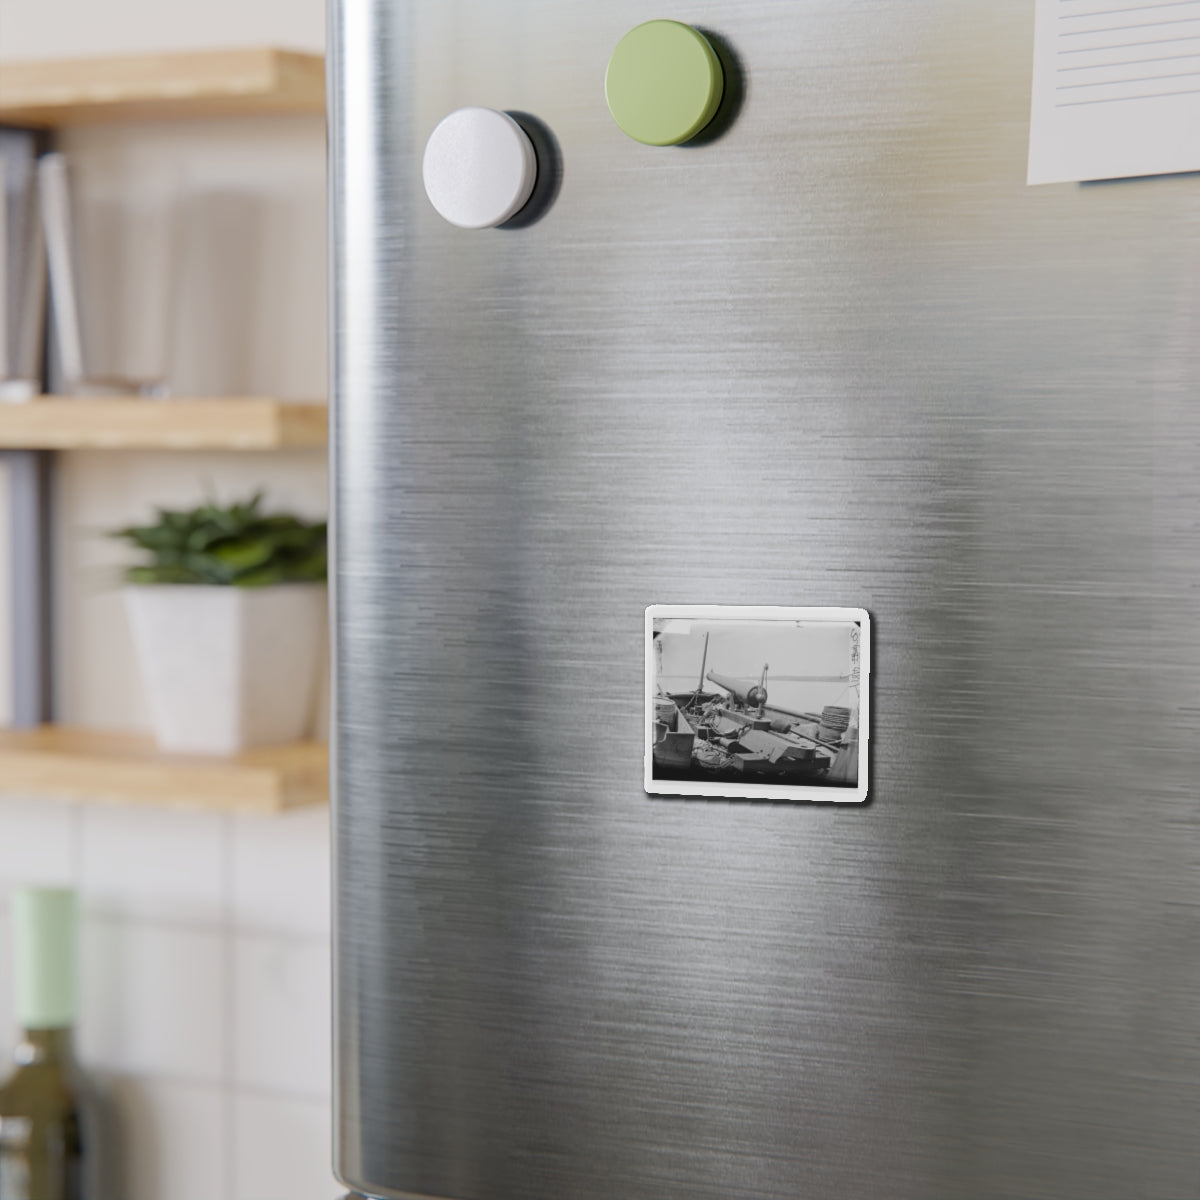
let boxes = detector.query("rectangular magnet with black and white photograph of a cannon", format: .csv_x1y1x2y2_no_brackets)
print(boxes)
646,605,870,803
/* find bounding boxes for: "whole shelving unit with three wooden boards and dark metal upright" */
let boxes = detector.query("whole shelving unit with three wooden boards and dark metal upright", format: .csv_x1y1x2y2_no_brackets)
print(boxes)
0,48,329,812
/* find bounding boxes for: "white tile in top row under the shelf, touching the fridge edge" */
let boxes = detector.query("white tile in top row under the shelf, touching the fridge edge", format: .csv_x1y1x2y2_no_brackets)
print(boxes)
233,806,330,936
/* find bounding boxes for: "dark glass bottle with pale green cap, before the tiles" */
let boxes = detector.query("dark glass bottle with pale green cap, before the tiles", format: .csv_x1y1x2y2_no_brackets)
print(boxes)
0,888,96,1200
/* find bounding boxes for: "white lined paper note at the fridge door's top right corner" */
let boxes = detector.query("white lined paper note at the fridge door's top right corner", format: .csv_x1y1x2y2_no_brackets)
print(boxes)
1028,0,1200,184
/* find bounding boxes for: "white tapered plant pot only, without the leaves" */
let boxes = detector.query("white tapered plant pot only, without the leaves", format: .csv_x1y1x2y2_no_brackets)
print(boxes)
125,583,325,755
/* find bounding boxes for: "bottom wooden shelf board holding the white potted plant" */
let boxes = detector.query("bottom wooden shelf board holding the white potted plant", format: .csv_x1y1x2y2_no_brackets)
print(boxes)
0,725,329,812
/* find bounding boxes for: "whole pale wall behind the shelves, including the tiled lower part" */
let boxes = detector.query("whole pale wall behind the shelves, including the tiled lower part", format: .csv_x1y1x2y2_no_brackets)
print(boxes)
0,0,340,1200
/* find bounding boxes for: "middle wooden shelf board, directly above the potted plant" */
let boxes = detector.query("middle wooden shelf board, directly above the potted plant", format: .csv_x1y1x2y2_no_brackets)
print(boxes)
0,396,328,450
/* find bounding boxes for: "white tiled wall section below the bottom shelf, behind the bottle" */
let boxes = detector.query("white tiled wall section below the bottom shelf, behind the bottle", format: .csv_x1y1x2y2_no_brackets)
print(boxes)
0,798,342,1200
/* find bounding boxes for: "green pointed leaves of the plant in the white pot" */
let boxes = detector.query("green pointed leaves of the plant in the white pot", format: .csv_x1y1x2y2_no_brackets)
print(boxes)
112,493,328,588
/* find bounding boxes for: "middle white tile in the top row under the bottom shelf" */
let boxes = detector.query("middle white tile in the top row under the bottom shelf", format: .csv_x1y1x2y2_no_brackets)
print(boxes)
80,805,224,926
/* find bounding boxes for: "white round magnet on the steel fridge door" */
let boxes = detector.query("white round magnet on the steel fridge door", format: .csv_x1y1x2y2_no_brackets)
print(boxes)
421,108,538,229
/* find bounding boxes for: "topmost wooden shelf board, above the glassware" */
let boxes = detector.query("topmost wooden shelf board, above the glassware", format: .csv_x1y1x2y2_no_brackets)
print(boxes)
0,49,325,127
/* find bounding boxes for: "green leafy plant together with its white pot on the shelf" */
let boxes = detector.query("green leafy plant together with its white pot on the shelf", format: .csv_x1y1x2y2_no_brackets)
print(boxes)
113,494,326,755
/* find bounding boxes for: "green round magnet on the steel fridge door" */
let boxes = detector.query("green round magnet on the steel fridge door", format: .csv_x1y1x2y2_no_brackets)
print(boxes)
604,20,725,146
